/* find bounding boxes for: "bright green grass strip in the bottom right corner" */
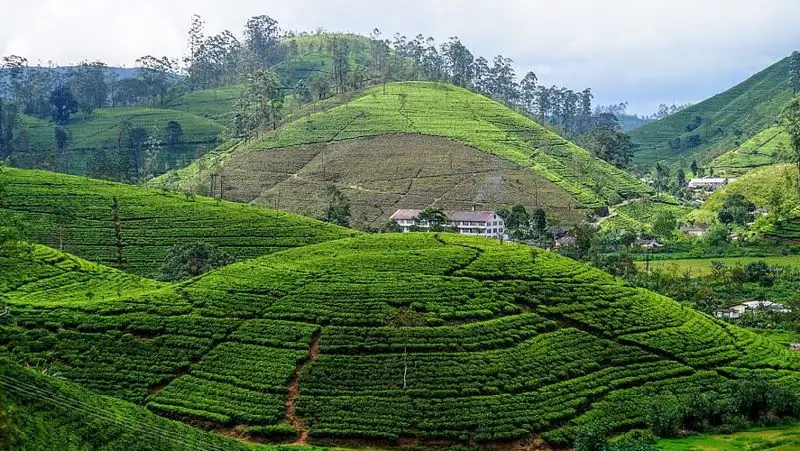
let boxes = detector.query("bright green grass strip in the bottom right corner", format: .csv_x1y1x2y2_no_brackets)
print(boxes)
656,424,800,451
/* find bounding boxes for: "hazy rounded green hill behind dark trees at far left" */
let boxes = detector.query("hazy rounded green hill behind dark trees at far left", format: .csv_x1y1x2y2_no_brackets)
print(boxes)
12,106,225,175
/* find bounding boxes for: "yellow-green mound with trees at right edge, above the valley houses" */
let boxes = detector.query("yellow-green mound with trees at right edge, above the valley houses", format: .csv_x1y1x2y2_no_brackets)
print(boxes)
702,164,800,240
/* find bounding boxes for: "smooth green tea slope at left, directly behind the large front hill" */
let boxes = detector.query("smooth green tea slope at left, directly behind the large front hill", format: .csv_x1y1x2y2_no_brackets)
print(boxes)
0,168,357,276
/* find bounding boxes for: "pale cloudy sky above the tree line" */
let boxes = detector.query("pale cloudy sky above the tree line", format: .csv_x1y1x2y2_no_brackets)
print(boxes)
0,0,800,113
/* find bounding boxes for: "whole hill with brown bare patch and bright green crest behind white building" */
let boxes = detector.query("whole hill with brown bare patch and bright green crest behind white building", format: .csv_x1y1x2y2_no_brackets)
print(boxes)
154,82,649,222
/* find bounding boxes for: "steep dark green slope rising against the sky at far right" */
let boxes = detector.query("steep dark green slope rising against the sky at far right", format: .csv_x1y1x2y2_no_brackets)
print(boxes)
630,58,792,166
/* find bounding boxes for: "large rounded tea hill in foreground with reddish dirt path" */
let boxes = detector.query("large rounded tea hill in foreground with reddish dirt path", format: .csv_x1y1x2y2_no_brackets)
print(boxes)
0,233,800,447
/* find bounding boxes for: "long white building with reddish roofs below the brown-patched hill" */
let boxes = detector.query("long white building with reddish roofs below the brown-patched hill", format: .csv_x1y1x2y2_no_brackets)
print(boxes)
390,209,506,238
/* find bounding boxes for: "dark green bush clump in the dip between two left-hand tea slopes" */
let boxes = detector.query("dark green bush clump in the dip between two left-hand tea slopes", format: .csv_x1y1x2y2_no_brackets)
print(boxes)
159,243,235,282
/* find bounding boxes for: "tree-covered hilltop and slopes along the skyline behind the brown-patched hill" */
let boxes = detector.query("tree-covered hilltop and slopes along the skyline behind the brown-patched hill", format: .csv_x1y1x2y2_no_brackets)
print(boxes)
0,16,640,187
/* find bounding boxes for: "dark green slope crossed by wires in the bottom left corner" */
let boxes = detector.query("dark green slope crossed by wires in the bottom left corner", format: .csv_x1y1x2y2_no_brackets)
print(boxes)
0,360,296,451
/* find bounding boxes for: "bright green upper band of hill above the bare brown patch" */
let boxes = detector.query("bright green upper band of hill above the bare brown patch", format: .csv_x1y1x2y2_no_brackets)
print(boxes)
156,82,648,214
